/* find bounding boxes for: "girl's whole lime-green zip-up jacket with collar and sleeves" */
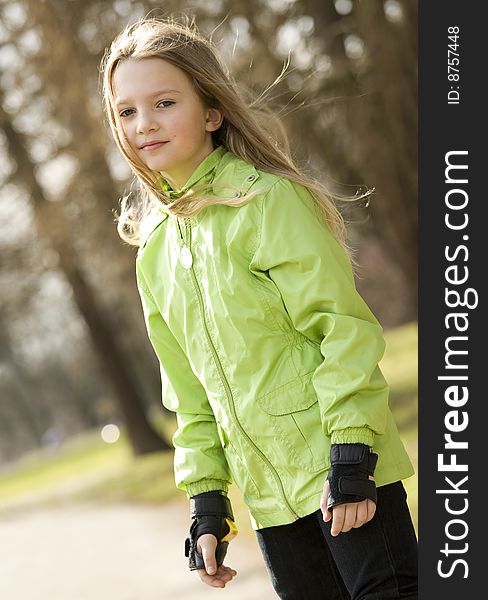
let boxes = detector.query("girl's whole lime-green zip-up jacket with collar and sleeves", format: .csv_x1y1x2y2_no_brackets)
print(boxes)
136,147,413,529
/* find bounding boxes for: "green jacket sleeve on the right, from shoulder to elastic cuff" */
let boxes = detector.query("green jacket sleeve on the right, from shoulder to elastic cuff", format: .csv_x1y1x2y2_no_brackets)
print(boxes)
253,179,389,446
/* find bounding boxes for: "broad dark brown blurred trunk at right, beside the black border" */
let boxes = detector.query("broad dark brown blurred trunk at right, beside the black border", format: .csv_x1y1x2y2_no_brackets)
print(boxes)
349,0,418,316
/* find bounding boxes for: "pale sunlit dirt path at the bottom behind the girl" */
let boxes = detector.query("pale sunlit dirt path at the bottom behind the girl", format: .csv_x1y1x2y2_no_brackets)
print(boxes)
0,502,277,600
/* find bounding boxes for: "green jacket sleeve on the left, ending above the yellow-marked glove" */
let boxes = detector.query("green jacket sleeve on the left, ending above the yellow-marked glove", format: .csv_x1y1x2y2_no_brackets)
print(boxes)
136,263,231,497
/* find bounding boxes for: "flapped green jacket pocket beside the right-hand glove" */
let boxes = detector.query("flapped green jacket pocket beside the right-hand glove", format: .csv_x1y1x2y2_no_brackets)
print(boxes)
257,371,330,473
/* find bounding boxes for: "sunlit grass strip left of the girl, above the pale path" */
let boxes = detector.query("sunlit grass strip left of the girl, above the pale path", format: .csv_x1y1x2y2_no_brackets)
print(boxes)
0,431,174,505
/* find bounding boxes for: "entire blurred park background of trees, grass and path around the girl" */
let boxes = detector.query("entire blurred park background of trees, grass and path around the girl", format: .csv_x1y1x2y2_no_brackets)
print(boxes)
0,0,418,600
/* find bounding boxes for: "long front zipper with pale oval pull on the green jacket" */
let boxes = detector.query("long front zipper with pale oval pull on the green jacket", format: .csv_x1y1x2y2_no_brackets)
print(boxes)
180,218,300,519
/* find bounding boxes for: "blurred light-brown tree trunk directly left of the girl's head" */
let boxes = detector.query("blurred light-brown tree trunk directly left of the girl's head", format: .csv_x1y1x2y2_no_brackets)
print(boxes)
25,0,165,411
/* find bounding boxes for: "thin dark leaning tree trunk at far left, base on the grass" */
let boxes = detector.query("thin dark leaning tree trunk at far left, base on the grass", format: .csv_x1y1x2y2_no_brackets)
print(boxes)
0,107,170,454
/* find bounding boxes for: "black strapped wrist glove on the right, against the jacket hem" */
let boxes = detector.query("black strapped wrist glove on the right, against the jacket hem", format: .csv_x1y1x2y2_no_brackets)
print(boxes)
327,444,378,510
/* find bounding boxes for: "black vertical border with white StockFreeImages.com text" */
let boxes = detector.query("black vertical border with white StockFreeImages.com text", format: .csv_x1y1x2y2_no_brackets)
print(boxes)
419,0,488,600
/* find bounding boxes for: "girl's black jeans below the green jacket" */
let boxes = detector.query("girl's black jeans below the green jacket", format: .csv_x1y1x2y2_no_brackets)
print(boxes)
256,481,418,600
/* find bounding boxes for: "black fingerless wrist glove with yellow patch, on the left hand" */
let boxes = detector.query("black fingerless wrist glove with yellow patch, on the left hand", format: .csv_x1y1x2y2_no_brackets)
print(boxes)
185,491,237,571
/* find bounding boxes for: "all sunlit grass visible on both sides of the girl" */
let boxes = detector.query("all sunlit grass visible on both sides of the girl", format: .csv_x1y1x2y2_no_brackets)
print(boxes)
0,323,417,534
